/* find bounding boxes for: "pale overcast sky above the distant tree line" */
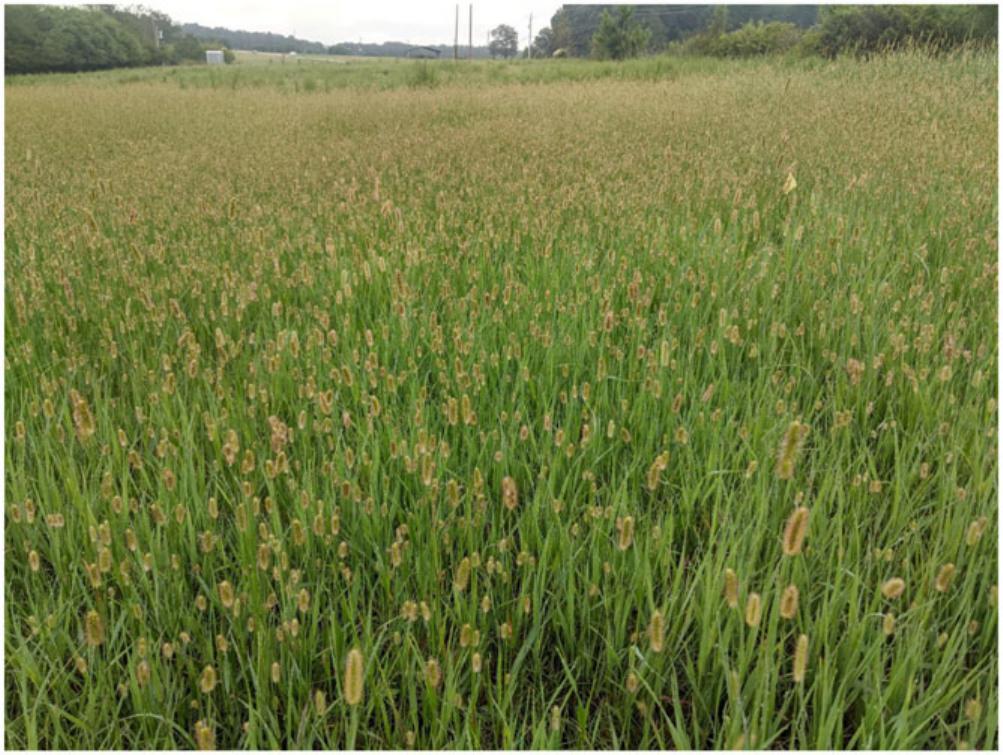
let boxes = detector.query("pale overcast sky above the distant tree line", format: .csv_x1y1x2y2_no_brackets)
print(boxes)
124,0,562,47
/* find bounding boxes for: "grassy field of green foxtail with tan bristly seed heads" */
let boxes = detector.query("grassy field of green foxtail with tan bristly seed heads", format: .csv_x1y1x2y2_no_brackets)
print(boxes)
4,52,999,749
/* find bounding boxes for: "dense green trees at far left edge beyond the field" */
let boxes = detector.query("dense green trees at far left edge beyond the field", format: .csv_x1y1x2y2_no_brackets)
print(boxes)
4,5,230,73
